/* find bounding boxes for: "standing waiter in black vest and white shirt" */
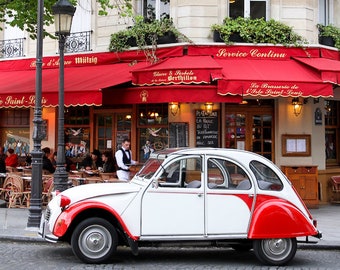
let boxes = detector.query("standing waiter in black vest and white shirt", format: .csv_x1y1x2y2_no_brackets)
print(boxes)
115,138,137,180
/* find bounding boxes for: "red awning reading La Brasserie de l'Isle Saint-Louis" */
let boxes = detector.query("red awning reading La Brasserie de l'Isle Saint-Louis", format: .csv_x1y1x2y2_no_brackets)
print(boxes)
215,59,333,97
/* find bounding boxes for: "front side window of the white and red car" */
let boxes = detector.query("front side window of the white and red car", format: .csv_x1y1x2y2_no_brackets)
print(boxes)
159,157,202,188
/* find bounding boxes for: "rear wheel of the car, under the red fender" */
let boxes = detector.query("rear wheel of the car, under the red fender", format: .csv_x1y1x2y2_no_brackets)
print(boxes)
253,238,297,266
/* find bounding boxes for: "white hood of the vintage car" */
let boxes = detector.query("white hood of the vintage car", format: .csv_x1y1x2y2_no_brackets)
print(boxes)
60,182,142,204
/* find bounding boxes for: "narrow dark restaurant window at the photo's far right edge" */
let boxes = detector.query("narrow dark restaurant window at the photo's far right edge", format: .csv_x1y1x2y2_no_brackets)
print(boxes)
325,100,340,166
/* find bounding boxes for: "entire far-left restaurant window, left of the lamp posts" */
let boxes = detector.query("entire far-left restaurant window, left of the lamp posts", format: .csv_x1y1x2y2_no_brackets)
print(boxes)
0,109,30,157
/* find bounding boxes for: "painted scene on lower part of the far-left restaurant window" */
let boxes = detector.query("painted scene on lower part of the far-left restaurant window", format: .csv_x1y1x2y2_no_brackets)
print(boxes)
1,128,30,157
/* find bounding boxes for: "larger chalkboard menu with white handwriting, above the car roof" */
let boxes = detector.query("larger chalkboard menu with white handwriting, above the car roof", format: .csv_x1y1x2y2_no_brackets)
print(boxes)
196,110,218,147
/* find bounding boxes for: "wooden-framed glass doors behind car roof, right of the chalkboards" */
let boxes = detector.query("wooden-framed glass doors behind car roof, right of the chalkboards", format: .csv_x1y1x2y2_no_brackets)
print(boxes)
225,100,275,161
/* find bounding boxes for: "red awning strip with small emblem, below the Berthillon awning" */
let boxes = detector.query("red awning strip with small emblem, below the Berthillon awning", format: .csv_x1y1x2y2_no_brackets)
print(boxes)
103,84,242,105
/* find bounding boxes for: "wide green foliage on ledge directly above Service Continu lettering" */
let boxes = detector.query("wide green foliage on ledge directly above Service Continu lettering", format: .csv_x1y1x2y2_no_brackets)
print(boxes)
211,17,307,46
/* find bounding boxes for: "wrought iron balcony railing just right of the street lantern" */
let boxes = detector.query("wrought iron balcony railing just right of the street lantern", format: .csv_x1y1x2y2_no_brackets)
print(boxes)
65,31,92,53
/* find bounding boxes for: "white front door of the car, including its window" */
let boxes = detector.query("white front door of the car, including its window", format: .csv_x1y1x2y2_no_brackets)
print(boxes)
141,155,204,239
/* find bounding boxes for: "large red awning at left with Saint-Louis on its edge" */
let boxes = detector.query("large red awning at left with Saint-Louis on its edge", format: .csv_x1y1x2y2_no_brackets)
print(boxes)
0,63,139,107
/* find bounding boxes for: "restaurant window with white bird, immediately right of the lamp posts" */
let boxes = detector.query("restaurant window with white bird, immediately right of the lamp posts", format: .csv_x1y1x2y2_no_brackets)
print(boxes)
64,106,90,158
